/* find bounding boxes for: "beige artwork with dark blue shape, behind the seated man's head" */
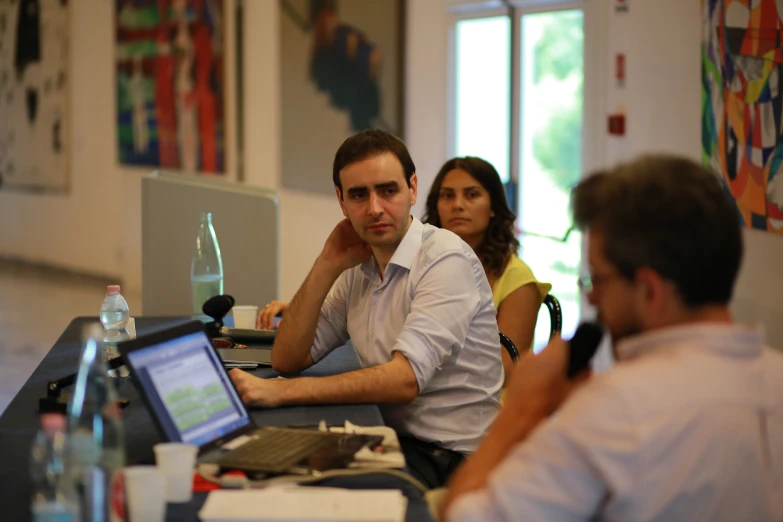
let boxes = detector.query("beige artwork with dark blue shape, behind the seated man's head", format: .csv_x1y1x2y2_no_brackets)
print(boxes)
279,0,405,194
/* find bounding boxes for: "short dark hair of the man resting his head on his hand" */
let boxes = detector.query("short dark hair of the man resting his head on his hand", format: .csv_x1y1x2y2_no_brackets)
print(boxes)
332,129,416,197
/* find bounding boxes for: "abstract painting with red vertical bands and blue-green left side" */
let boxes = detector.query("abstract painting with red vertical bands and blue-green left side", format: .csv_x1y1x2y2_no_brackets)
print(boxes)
116,0,226,174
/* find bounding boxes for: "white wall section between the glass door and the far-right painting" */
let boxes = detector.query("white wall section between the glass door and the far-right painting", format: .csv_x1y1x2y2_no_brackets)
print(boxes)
601,0,701,160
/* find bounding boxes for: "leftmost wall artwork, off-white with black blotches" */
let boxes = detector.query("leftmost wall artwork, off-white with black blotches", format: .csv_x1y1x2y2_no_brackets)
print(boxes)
0,0,70,193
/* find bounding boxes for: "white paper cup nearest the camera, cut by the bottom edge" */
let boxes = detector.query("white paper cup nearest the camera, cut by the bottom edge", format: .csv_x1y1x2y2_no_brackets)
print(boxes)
122,466,166,522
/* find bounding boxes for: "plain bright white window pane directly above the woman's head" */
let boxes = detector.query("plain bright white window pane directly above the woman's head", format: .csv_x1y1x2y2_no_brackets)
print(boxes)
455,16,511,182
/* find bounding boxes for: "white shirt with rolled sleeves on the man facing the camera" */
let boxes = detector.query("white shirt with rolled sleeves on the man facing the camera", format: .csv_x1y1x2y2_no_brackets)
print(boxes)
310,217,503,453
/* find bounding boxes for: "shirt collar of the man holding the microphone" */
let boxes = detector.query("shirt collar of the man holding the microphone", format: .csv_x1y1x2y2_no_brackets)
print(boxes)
617,323,765,361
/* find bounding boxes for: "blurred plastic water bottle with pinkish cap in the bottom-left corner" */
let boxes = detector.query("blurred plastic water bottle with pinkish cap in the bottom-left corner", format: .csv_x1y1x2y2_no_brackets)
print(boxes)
30,413,81,522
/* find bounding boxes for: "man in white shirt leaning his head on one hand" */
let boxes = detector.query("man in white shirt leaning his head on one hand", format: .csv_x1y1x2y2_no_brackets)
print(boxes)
231,130,503,487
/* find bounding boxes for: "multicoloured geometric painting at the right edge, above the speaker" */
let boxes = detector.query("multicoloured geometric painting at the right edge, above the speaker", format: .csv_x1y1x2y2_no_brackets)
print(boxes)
702,0,783,234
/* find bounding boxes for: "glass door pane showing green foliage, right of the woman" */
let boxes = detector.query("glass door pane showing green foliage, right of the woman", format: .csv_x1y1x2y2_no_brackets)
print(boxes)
518,9,584,348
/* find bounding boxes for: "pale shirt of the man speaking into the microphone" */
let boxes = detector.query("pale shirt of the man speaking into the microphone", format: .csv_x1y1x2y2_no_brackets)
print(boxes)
449,323,783,522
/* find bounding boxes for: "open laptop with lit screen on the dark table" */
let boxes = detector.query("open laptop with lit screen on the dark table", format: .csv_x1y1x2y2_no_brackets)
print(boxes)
119,321,382,474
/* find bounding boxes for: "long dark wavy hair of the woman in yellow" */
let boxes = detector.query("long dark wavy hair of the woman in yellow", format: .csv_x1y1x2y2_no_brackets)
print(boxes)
424,156,519,276
